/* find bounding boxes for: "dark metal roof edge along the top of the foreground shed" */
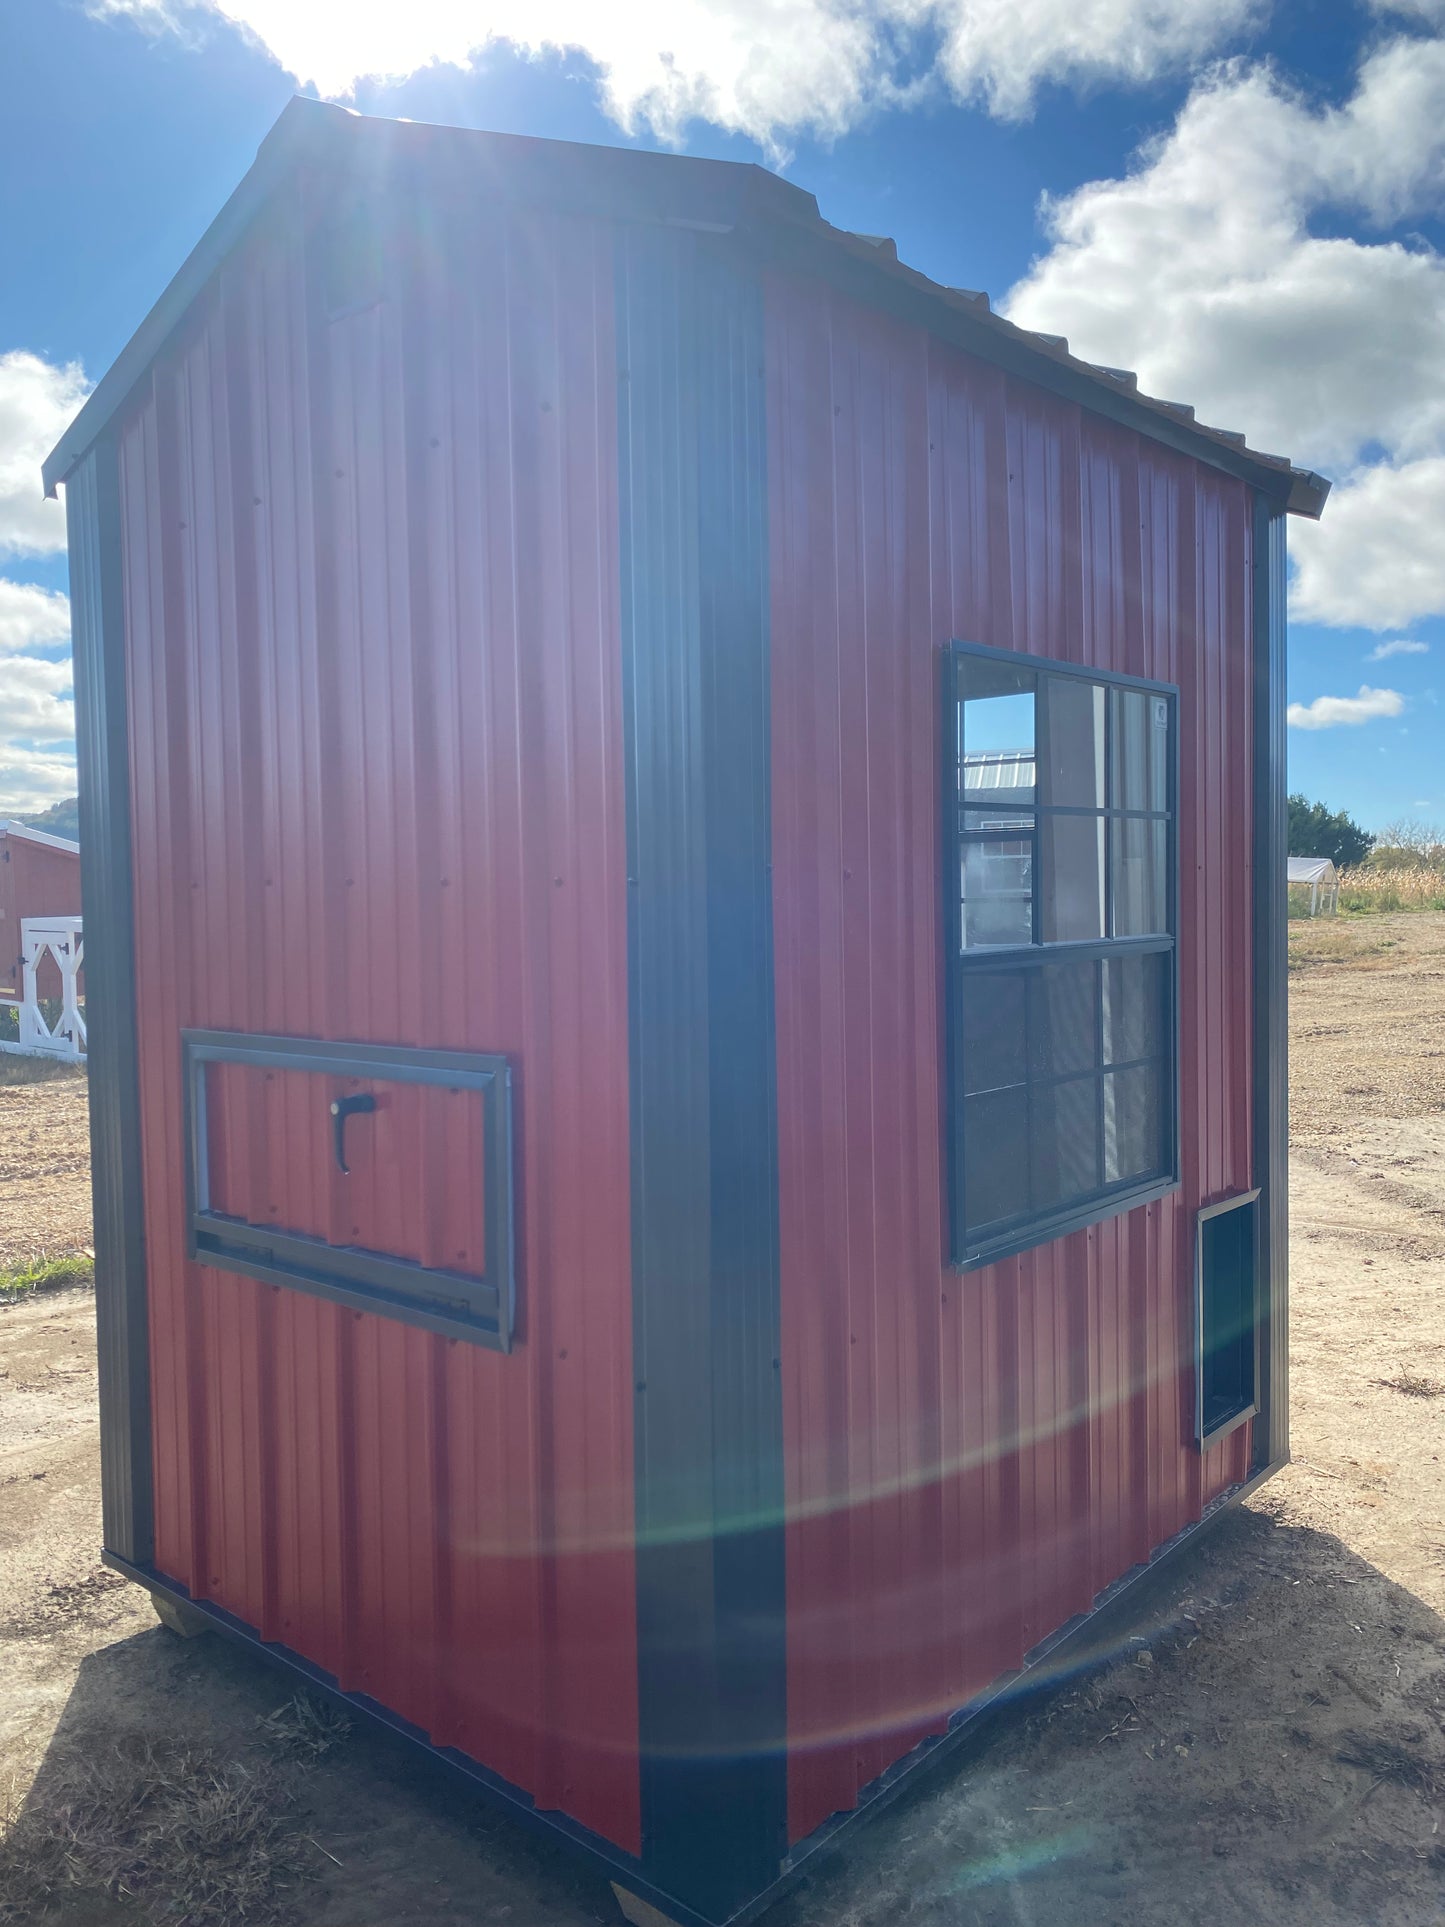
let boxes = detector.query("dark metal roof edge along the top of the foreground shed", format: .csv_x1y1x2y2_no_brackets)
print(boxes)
42,96,1329,518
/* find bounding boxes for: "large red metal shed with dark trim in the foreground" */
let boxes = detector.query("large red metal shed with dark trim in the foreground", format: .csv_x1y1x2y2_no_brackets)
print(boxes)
46,100,1327,1927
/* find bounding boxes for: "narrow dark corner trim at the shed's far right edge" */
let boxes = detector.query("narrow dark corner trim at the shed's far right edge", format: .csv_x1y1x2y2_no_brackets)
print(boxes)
1252,495,1289,1468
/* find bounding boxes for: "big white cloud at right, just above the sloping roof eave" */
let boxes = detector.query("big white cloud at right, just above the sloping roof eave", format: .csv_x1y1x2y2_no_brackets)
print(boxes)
1008,39,1445,628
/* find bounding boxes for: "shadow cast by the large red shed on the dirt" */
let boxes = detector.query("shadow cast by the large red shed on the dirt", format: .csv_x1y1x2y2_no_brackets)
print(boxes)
0,1507,1445,1927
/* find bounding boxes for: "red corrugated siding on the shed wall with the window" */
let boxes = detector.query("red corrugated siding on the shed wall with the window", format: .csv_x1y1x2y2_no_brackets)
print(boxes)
769,276,1250,1838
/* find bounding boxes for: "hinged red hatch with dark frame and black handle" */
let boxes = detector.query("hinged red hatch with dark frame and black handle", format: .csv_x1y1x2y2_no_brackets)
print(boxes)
181,1031,514,1351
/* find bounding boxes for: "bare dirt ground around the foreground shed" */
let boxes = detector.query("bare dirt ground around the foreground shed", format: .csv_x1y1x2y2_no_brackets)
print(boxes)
0,915,1445,1927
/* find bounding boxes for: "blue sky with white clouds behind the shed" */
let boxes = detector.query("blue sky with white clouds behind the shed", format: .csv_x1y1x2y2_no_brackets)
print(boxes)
0,0,1445,827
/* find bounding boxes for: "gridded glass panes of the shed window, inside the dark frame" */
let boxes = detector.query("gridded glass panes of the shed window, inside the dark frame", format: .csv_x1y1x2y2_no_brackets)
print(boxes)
950,655,1175,1256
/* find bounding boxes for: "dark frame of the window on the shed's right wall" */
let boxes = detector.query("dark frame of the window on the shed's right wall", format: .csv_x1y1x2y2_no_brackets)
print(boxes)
938,640,1181,1272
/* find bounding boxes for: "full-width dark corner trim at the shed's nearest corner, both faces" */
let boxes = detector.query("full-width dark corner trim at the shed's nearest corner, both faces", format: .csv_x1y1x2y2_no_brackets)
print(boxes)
617,227,786,1919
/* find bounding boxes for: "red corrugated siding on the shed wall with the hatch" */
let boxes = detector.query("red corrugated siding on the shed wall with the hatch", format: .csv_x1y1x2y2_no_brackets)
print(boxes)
121,191,640,1850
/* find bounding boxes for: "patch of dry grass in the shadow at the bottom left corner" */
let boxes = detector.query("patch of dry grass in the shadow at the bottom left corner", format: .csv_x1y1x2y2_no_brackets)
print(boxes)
0,1740,322,1927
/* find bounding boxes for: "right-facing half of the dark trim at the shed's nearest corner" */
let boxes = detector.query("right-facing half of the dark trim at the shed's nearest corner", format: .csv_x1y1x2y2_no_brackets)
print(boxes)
694,245,788,1898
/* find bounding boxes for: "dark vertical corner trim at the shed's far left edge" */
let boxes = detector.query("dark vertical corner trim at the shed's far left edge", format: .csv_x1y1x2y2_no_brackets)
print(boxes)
66,437,154,1565
